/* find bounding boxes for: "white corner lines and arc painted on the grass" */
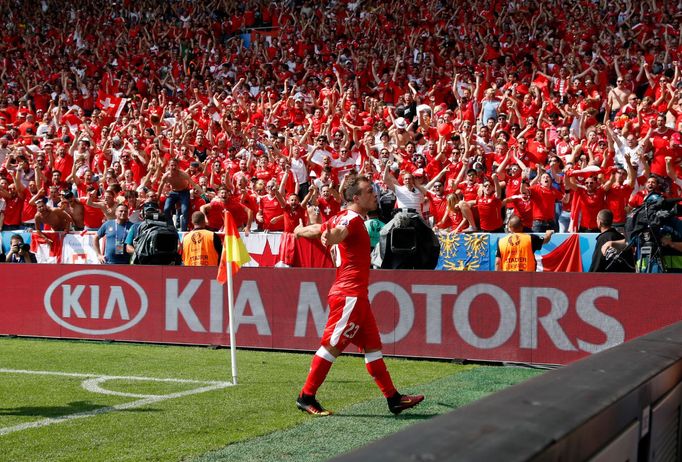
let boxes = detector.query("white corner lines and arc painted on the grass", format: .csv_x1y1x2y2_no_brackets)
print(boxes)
0,369,233,436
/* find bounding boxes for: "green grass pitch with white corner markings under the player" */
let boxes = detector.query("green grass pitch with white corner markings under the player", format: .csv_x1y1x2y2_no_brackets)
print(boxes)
0,338,541,462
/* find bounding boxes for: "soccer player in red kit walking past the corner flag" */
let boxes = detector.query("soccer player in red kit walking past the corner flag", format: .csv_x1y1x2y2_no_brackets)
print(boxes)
294,176,424,416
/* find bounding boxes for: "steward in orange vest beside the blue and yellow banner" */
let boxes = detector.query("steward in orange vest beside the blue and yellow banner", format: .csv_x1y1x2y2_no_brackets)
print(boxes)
495,215,554,271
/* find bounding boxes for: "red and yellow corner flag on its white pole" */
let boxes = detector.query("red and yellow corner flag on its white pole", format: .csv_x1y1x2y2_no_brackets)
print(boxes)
216,210,251,385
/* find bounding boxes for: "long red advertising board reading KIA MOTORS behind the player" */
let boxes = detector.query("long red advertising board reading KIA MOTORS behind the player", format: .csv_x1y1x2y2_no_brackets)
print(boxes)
0,265,682,364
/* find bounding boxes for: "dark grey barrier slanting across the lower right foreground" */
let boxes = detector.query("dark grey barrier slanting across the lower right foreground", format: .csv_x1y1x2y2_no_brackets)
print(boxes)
332,322,682,462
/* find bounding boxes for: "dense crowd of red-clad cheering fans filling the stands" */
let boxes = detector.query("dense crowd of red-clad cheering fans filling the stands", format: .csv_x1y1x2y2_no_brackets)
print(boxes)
0,0,682,253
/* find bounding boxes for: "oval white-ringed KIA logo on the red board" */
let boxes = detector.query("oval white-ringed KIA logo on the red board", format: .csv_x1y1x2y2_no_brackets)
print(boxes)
43,270,148,335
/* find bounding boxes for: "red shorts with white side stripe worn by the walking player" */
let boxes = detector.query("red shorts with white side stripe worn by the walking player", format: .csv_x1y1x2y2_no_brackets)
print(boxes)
321,295,381,351
